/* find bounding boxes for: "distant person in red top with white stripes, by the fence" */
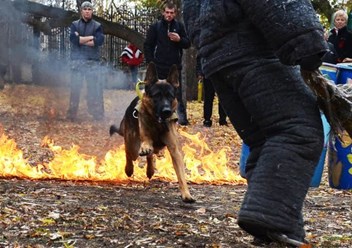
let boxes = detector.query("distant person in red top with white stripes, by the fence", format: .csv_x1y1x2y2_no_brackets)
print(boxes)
121,43,144,89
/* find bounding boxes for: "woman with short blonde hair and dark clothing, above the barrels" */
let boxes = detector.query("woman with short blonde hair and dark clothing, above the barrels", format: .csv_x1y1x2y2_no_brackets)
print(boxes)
324,10,352,64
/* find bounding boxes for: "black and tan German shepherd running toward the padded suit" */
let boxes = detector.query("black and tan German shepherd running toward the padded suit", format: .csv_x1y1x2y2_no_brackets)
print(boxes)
110,62,195,203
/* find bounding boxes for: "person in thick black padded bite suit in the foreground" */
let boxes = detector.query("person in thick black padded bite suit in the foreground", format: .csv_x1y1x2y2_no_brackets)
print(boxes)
183,0,327,246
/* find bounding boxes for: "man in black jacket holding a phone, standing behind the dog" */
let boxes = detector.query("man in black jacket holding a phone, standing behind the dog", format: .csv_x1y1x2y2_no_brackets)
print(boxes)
144,3,191,125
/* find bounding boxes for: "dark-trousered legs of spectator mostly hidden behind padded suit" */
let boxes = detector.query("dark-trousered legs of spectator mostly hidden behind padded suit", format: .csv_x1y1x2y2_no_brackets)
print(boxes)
196,58,227,127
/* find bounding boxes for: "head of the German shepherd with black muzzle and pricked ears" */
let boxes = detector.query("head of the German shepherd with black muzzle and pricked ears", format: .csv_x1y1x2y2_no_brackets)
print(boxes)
143,62,179,122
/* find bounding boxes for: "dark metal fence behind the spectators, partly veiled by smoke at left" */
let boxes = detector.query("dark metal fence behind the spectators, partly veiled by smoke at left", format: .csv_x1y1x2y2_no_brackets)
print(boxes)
0,0,196,99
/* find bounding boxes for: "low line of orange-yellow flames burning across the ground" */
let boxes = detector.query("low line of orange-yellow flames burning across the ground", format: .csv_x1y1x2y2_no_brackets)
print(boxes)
0,130,246,185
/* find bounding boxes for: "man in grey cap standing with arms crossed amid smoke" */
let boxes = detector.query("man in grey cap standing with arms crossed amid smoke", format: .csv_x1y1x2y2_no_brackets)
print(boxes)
67,1,104,121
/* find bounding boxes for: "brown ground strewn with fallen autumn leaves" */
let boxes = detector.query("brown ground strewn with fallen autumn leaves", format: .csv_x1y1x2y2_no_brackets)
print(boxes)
0,85,352,248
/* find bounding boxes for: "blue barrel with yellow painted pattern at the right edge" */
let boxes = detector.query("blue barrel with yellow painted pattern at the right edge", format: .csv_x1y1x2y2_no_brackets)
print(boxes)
328,133,352,189
